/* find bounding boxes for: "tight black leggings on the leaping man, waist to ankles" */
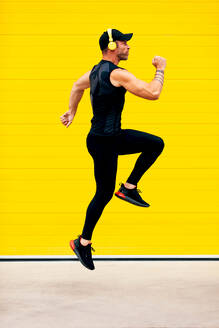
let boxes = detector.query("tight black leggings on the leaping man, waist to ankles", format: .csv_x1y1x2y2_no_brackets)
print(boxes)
82,129,164,240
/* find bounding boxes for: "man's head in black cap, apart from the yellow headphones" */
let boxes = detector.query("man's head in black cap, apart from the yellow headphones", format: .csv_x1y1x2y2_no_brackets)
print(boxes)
99,29,133,60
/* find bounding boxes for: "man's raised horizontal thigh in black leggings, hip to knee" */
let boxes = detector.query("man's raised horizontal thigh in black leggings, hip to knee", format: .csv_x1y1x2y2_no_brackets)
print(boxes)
116,129,161,155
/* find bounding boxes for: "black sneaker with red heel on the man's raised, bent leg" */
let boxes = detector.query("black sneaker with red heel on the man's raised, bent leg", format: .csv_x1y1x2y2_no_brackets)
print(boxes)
115,183,150,207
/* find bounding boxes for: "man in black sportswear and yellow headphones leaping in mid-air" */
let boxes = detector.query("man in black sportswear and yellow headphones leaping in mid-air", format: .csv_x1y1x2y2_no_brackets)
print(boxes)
60,29,166,270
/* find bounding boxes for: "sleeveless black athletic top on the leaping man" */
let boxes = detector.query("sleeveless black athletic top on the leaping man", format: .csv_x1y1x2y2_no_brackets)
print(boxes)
89,59,127,136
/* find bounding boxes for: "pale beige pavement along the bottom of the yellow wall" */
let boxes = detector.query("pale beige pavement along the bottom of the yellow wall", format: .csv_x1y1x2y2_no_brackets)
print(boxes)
0,261,219,328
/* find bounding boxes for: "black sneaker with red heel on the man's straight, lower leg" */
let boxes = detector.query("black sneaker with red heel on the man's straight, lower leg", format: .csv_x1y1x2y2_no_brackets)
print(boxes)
70,235,95,270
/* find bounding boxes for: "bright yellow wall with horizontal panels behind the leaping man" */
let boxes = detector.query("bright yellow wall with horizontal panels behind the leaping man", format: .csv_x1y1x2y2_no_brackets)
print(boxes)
0,0,219,255
